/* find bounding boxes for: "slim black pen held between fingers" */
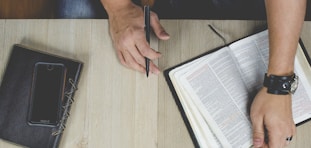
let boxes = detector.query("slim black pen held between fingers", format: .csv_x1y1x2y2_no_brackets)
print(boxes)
144,5,150,77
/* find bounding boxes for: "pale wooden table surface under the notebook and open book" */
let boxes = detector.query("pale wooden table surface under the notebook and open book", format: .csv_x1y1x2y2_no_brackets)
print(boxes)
0,20,311,148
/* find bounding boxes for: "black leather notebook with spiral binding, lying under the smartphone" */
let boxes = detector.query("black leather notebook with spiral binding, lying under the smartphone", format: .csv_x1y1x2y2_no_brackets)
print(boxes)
0,45,83,148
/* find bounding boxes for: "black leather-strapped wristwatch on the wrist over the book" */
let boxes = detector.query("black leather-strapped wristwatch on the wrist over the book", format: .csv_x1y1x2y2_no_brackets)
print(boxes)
263,73,298,95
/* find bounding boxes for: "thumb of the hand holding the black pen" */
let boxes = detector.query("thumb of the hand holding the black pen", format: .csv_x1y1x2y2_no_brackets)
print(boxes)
150,11,170,40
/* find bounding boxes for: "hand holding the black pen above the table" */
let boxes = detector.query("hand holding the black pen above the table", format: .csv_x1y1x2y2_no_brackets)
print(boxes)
109,3,169,74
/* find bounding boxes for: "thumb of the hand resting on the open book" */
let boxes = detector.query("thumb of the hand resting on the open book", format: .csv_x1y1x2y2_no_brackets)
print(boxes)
252,119,265,148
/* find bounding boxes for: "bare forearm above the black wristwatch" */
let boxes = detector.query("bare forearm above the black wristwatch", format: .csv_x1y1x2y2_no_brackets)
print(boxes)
266,0,306,75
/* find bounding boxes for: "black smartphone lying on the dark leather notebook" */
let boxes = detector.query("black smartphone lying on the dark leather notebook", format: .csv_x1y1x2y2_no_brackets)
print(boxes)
28,62,66,126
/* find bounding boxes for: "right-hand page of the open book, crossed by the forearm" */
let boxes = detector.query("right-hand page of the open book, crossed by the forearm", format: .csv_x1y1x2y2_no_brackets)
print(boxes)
229,30,311,124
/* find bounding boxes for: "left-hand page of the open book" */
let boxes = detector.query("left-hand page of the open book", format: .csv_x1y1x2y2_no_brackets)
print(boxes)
176,48,252,147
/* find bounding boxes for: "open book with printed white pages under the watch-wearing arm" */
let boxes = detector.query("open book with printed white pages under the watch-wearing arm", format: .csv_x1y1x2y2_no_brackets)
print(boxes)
165,30,311,148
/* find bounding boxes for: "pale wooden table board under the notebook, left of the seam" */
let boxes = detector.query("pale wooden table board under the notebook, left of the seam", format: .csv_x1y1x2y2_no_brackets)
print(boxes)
0,20,158,148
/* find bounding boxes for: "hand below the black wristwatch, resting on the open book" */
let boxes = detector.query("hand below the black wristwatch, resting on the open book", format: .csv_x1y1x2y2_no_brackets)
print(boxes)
250,87,296,148
